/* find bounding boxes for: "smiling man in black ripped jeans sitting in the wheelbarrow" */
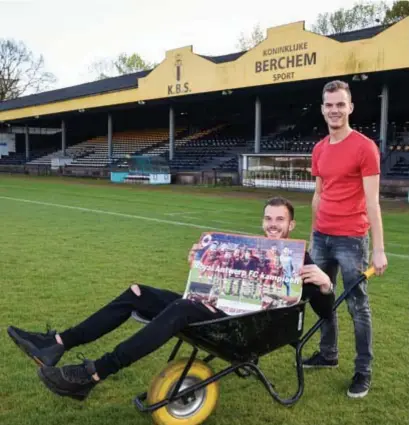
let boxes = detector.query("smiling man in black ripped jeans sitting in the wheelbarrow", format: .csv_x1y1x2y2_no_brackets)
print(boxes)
8,197,335,400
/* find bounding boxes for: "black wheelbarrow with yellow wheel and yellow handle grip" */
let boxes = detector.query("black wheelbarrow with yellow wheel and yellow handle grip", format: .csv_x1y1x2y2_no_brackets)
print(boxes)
133,267,375,425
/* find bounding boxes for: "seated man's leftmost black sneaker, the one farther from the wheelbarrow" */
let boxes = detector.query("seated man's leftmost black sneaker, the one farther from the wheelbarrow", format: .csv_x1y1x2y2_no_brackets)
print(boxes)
7,326,65,366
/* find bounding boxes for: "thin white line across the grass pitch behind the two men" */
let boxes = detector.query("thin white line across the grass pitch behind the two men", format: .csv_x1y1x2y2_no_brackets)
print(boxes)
0,196,409,259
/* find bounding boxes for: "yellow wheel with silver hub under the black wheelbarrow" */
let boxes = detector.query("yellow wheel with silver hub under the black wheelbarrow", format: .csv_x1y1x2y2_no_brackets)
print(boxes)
147,359,219,425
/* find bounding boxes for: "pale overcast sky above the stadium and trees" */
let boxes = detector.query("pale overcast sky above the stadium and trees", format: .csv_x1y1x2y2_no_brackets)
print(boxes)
0,0,364,88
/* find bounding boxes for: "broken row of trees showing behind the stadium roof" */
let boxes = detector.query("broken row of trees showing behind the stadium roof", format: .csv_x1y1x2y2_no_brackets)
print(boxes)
0,0,409,102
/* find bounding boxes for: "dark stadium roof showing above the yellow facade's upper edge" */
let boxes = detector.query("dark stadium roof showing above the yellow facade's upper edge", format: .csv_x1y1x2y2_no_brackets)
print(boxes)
0,25,388,111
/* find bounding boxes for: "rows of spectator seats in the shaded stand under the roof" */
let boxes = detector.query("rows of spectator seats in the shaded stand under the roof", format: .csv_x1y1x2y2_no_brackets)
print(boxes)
0,114,409,176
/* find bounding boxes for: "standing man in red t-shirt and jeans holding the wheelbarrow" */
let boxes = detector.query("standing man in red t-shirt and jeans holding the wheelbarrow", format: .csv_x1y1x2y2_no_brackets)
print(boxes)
303,81,387,398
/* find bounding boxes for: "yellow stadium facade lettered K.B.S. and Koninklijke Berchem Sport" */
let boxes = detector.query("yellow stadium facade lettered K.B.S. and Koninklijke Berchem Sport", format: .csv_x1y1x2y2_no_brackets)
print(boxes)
0,17,409,121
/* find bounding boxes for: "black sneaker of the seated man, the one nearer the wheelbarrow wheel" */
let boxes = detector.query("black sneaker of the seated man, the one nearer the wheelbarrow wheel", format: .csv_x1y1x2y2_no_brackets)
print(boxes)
38,360,97,401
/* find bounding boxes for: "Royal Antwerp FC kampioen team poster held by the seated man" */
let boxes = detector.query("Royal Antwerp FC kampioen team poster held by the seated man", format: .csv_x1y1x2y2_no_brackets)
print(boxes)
183,232,306,315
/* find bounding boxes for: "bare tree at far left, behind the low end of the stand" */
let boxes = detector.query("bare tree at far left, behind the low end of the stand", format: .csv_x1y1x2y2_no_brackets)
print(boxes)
0,39,56,102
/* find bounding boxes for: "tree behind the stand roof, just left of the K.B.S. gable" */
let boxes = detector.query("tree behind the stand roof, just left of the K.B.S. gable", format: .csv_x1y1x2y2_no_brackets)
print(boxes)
89,53,156,80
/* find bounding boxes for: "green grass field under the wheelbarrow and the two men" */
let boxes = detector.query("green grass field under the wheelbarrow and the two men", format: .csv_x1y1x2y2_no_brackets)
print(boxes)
0,176,409,425
